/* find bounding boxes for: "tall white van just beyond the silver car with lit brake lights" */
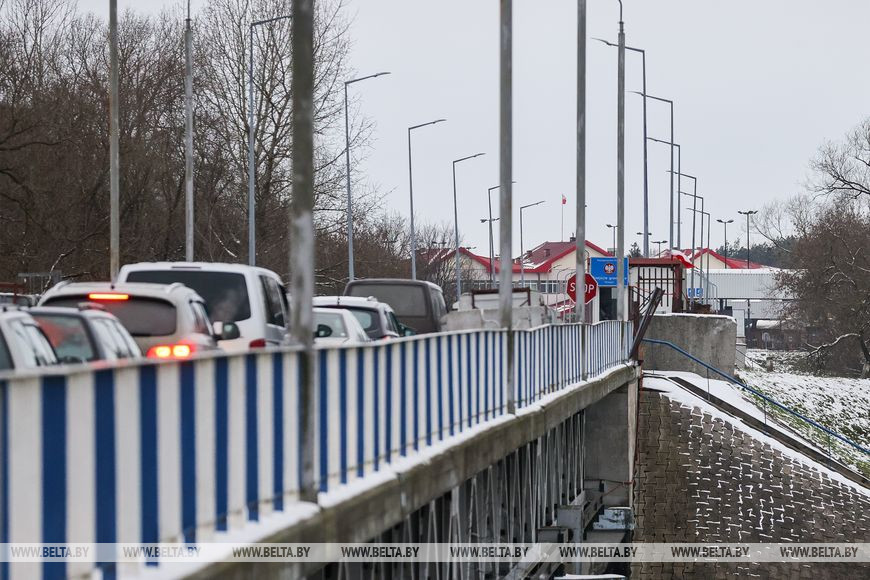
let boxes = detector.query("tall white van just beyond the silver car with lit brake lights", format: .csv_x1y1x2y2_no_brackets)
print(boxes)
118,262,289,352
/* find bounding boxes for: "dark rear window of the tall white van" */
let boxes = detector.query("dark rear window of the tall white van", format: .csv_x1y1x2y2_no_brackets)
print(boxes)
125,270,251,326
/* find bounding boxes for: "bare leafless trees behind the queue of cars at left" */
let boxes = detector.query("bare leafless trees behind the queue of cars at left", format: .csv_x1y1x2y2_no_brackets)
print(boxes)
0,0,460,292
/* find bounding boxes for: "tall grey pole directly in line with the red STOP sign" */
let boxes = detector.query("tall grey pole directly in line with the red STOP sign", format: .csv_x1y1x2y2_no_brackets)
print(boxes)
574,0,586,322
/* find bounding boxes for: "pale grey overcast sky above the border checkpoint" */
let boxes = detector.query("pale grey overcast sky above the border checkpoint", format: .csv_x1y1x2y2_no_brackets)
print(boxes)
80,0,870,254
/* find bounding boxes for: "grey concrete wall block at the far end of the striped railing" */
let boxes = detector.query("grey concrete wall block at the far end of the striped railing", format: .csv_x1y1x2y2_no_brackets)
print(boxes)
641,314,737,376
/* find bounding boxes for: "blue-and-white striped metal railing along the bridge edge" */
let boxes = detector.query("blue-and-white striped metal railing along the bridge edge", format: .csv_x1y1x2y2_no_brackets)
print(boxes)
0,322,631,578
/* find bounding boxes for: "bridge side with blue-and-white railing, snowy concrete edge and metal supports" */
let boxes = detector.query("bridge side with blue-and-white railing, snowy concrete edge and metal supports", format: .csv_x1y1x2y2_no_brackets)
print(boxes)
0,321,638,579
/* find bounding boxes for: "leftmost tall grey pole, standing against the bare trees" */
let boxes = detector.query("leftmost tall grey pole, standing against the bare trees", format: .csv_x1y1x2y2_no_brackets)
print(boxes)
109,0,121,282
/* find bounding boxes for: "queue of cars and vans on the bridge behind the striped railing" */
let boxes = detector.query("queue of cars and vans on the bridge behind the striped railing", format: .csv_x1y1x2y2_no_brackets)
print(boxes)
0,262,446,371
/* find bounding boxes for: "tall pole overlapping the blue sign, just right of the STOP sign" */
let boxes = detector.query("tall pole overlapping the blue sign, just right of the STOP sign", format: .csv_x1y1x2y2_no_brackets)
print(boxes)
616,0,628,321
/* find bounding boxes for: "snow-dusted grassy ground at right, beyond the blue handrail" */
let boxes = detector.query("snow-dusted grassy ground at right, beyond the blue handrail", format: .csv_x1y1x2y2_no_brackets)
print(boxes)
740,350,870,476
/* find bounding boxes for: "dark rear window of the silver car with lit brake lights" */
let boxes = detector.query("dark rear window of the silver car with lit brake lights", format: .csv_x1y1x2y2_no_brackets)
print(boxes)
45,296,177,336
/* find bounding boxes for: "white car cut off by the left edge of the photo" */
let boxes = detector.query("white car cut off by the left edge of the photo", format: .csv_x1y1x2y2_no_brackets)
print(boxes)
0,308,57,371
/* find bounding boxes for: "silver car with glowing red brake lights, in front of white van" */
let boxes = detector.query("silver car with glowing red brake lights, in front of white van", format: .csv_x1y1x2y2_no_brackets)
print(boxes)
39,282,239,359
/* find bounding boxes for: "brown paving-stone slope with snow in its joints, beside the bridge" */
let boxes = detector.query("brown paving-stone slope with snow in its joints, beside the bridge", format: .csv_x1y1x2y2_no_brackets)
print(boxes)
632,390,870,580
